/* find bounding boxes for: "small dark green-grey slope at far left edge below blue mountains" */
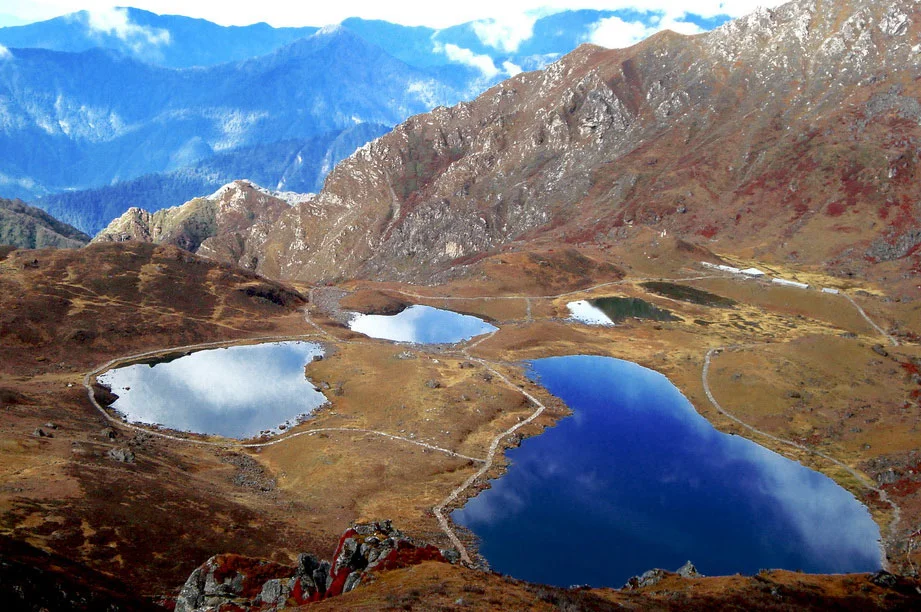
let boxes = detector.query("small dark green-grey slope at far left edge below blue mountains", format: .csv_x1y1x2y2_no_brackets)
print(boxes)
0,199,90,249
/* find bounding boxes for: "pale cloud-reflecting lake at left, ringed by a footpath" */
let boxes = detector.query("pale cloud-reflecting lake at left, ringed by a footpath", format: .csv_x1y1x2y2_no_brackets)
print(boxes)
98,342,326,438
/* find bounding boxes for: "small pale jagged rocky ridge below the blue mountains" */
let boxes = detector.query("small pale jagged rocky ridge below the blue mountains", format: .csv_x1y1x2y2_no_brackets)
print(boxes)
93,181,310,270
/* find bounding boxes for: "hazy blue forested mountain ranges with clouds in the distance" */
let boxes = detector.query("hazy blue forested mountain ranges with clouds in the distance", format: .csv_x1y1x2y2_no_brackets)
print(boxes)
0,8,718,233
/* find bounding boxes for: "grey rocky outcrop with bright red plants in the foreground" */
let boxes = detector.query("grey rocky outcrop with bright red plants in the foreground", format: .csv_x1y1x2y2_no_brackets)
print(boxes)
176,521,458,612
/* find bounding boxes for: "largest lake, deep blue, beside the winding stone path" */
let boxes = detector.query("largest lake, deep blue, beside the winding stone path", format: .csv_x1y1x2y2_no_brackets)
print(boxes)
452,356,882,587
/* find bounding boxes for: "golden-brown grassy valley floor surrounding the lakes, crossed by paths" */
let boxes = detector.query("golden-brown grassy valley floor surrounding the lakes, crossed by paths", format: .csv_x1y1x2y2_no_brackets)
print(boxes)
0,235,921,609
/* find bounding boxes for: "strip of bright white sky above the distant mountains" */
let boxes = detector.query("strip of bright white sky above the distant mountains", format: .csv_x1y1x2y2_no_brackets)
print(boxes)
0,0,781,32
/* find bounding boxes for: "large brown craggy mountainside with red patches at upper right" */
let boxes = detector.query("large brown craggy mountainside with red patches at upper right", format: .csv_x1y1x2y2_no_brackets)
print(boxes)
258,0,921,281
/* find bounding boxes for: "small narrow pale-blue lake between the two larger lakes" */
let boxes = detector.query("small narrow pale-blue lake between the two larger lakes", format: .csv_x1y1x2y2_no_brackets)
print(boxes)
349,305,497,344
